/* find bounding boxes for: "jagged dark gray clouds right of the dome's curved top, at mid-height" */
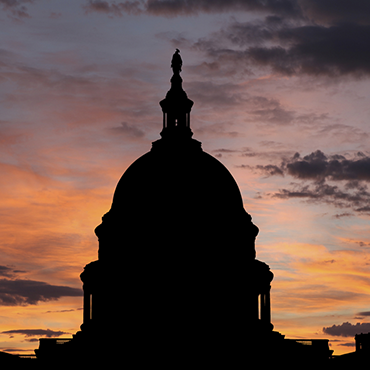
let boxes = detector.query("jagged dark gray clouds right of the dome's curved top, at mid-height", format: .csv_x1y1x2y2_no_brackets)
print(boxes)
250,150,370,214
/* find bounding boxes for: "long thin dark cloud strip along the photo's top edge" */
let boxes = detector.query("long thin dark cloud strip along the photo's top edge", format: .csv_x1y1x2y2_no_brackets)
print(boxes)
83,0,370,24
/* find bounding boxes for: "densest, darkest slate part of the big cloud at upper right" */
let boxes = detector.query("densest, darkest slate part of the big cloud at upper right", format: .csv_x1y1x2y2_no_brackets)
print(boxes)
248,23,370,76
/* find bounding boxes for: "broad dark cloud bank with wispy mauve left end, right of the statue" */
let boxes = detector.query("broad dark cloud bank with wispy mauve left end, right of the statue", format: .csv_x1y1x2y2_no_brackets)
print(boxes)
192,16,370,77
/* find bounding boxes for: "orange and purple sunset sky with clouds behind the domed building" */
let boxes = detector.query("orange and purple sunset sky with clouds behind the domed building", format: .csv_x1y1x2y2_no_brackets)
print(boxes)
0,0,370,354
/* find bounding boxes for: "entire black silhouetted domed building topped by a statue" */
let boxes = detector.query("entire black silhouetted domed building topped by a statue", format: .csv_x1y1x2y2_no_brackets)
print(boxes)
3,51,368,369
